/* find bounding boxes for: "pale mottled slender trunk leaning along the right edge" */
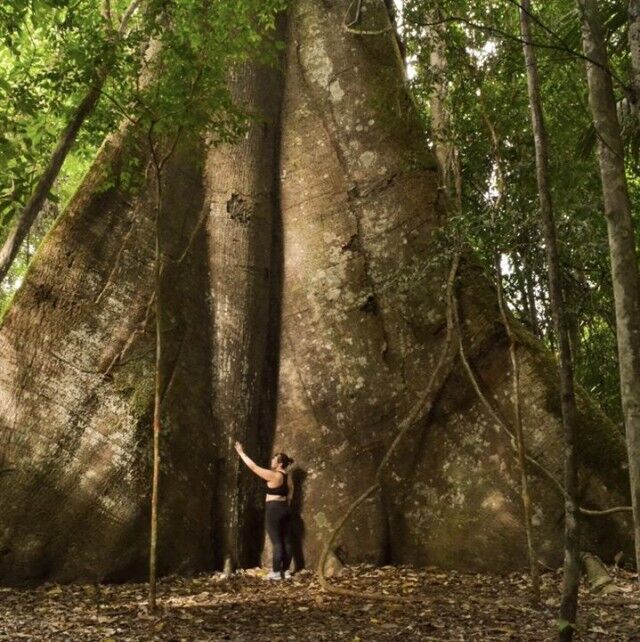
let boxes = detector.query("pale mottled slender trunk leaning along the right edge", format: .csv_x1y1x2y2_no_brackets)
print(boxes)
578,0,640,578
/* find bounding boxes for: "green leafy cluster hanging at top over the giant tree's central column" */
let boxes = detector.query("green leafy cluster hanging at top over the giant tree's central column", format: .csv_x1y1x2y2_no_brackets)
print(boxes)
135,0,284,140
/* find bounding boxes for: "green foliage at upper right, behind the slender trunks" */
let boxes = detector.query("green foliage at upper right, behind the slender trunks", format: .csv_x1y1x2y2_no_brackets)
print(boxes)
403,0,640,422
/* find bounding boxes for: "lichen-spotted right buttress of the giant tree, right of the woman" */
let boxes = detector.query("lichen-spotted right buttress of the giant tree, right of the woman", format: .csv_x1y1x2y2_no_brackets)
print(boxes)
276,0,628,570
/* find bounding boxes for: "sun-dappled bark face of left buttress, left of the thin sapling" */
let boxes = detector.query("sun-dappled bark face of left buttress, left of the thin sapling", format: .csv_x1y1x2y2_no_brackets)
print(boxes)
0,125,158,581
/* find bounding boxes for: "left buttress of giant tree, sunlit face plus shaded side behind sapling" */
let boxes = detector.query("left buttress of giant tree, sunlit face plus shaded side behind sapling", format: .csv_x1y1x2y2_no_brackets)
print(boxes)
0,122,218,582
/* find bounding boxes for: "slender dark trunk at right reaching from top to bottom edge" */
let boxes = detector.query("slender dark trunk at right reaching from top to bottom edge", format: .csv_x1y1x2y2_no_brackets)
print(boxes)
520,0,580,640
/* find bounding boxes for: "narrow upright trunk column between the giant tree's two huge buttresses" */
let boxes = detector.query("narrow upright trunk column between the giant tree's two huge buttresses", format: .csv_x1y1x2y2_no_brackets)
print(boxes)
205,53,283,568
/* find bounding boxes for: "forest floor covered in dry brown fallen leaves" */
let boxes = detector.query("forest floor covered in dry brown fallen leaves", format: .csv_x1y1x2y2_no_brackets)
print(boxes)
0,566,640,642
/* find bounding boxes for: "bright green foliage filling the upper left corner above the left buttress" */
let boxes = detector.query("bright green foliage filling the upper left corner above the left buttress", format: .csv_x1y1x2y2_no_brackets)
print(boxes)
0,0,286,307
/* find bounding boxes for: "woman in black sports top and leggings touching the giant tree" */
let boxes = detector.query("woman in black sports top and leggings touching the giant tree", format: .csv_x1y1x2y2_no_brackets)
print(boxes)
235,441,293,580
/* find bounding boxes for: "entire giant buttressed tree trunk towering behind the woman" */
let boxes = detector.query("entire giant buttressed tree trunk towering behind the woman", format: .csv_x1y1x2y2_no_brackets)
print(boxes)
0,0,628,582
